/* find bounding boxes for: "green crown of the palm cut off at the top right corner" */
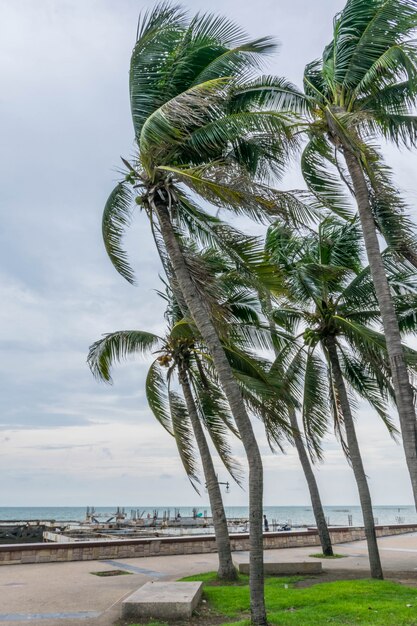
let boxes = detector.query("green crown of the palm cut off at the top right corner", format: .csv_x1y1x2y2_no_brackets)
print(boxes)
303,0,417,263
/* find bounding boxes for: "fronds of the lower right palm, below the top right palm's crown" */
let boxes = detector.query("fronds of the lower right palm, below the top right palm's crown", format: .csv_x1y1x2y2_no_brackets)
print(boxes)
266,217,417,446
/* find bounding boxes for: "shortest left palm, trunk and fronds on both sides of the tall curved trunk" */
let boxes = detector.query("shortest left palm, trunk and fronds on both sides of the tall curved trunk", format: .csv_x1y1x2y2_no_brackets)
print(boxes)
88,260,289,580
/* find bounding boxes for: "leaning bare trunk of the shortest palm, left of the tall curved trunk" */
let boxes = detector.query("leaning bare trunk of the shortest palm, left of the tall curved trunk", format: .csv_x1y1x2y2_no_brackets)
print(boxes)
179,371,237,581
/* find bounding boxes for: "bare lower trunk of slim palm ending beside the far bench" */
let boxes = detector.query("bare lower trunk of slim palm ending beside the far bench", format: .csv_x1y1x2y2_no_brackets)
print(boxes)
289,408,333,556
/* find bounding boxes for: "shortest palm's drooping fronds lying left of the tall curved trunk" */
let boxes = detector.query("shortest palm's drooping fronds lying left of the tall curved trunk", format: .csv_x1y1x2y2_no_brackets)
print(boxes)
88,320,240,492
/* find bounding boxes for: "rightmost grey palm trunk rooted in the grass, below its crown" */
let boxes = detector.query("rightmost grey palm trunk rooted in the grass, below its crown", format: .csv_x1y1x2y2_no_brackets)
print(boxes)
325,336,384,580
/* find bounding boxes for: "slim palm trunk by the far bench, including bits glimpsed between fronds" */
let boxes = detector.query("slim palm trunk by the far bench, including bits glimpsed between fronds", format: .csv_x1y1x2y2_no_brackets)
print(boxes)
259,294,333,556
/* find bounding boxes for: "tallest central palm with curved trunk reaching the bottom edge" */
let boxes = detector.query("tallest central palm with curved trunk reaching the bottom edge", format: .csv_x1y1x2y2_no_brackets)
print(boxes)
98,4,305,626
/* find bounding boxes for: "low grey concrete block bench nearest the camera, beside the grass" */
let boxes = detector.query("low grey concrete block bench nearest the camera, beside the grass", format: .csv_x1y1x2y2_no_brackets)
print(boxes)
122,582,203,620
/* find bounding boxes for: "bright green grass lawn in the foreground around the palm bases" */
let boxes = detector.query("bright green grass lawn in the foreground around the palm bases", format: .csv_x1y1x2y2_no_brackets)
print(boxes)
127,573,417,626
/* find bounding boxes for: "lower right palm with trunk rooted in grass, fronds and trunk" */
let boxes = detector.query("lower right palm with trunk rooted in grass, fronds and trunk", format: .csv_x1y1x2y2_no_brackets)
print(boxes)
267,217,417,578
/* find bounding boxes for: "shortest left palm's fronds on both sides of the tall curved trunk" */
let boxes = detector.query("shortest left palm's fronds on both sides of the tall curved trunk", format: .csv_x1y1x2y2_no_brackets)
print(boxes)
88,254,291,478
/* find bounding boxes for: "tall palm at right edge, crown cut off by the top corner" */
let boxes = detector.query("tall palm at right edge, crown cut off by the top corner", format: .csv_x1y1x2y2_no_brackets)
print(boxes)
245,0,417,505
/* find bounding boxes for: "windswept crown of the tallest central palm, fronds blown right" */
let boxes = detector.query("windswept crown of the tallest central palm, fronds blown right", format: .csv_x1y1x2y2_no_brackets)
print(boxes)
103,5,310,281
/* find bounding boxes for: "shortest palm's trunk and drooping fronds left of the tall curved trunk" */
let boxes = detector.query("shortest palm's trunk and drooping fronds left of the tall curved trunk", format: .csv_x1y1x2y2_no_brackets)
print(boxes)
88,307,240,580
